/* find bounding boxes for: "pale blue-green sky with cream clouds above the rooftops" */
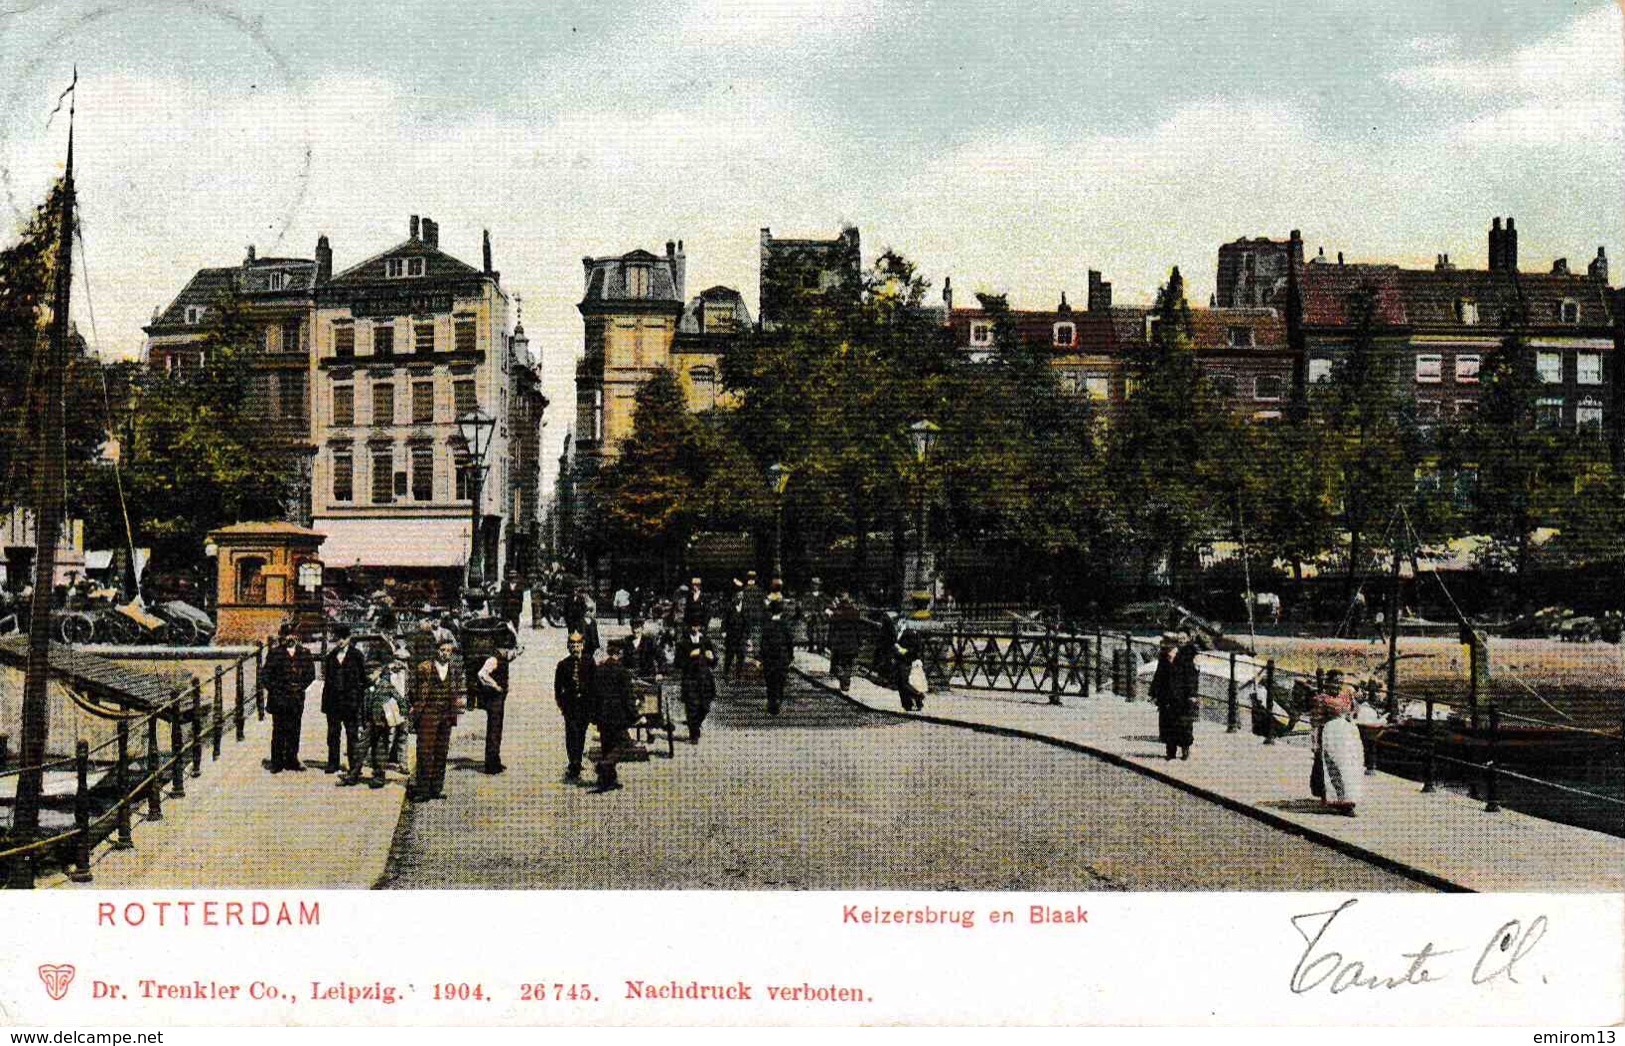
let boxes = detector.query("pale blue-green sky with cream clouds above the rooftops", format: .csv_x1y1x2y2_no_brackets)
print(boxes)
0,0,1625,458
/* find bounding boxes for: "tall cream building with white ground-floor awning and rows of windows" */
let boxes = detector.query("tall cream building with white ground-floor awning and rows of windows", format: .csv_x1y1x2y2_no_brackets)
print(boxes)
310,216,516,596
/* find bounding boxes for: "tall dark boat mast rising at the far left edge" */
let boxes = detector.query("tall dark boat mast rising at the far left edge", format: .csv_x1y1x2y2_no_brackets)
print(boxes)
11,87,78,887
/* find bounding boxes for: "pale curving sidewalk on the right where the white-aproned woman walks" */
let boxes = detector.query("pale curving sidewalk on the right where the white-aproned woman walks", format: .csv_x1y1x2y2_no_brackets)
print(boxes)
796,651,1625,892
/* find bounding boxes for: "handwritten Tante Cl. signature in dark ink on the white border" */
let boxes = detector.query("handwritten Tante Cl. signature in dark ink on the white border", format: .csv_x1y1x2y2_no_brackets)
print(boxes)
1290,898,1547,996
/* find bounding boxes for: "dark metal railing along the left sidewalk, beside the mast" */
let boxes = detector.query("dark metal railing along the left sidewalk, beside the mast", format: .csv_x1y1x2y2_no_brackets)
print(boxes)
0,643,265,888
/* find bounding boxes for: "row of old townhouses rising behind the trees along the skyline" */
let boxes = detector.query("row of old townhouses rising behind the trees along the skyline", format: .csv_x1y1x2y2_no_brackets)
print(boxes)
146,218,1625,585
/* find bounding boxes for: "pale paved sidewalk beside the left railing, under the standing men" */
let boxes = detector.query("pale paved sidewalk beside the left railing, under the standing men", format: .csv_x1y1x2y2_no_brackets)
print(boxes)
39,685,406,890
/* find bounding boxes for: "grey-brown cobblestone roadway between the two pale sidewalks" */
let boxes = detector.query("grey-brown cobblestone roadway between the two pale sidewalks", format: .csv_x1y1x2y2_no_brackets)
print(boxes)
385,620,1417,890
